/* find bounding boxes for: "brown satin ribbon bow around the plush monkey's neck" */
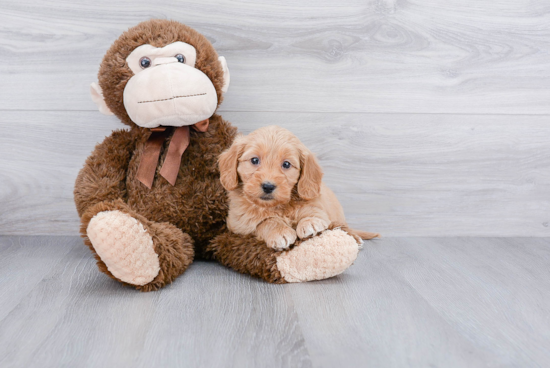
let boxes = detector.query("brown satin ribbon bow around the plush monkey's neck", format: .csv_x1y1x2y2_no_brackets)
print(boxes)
136,119,209,189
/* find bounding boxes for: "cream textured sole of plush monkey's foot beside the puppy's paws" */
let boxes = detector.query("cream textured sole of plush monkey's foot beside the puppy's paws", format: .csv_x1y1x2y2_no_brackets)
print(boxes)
277,229,359,282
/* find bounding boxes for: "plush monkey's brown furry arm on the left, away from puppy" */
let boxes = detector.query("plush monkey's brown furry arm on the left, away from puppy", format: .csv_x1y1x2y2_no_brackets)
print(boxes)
74,130,136,217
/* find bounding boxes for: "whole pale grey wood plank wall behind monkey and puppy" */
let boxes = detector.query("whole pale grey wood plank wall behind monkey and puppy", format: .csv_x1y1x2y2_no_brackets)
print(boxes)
0,0,550,236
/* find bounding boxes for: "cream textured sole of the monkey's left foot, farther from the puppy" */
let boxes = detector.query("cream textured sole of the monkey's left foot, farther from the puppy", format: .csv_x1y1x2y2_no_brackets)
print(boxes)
86,210,160,286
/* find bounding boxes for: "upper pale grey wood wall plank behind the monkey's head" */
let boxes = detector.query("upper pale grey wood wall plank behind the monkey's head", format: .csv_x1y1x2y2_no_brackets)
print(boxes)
0,0,550,114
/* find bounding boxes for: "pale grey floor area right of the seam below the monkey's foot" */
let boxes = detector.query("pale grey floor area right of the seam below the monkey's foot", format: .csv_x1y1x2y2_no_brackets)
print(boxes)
289,237,550,367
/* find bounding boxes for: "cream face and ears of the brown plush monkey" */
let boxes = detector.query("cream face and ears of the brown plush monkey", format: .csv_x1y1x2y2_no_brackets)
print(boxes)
92,41,229,128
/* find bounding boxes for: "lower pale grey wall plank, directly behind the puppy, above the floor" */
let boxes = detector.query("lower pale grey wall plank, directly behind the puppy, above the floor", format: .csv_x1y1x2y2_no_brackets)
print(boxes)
0,111,550,236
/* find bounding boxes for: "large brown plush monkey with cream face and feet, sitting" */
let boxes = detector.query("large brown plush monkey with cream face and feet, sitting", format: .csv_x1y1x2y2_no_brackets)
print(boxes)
74,20,366,291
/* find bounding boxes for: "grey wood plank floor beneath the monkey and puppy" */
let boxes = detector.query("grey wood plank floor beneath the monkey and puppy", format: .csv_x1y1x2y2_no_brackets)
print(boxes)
0,236,550,367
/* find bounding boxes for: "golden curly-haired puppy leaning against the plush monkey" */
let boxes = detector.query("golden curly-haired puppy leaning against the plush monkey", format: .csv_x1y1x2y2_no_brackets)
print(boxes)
219,126,378,250
